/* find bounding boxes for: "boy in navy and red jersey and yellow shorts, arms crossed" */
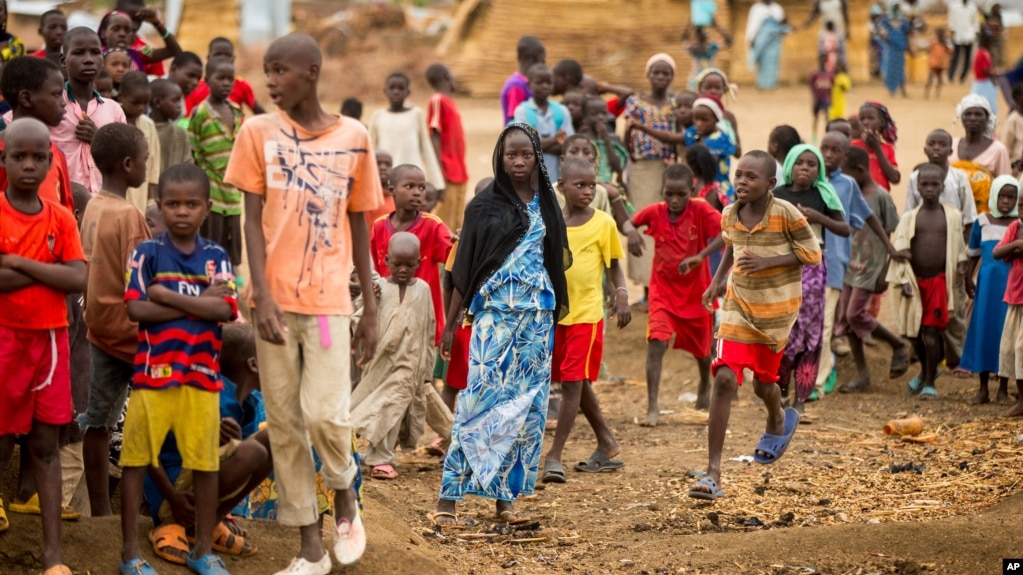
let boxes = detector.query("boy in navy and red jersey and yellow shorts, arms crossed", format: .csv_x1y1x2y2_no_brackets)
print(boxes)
120,164,238,575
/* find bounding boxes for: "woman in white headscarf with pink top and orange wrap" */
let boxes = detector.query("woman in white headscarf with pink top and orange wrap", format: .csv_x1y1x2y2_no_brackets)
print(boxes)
948,94,1012,214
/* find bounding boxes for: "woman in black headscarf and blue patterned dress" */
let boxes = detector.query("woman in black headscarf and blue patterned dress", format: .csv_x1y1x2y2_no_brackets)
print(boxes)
431,124,572,525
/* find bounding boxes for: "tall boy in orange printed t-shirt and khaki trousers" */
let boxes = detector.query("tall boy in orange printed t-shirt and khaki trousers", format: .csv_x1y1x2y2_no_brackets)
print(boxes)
224,34,382,575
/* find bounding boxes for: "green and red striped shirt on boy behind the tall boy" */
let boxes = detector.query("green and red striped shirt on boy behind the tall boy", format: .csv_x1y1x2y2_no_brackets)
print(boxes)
188,100,241,216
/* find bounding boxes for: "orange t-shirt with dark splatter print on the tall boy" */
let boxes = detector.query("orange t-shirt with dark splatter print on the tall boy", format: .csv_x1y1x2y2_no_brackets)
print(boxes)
224,112,382,315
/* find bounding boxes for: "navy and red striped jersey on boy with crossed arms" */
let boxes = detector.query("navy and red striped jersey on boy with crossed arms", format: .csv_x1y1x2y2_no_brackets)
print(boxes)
125,233,238,392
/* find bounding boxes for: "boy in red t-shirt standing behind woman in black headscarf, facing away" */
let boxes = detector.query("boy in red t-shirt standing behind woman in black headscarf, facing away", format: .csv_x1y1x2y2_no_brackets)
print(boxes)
427,63,469,229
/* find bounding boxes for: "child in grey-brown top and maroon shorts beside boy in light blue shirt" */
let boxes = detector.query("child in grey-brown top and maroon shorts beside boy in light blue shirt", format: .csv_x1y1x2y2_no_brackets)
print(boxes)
835,147,909,393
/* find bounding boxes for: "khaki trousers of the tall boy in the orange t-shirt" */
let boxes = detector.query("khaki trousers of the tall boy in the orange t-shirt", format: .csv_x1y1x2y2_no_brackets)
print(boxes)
256,312,358,527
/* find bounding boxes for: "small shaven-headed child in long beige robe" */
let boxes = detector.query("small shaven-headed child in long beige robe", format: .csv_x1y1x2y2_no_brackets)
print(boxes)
352,233,435,479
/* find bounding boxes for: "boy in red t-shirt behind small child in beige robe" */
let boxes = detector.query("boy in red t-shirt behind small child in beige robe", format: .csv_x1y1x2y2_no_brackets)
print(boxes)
369,164,451,345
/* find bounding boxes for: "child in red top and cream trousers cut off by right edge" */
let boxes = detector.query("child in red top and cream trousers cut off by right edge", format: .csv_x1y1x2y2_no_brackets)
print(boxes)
991,188,1023,417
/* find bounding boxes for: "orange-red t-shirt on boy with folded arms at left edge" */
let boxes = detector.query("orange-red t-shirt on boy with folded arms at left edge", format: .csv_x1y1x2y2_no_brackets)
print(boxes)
0,193,85,329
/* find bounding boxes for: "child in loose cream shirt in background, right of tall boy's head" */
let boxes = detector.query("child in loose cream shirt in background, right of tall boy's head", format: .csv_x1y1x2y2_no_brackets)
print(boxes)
369,72,444,192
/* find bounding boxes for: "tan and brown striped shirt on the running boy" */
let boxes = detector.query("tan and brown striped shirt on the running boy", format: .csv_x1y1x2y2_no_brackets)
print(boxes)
717,191,821,351
